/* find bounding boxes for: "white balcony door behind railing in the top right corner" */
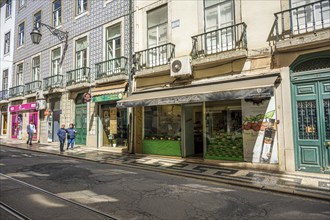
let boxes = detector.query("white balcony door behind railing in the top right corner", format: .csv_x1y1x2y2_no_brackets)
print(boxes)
291,0,330,34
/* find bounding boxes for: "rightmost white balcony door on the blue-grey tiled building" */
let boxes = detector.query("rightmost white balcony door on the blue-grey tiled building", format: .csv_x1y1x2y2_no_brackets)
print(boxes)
105,24,121,75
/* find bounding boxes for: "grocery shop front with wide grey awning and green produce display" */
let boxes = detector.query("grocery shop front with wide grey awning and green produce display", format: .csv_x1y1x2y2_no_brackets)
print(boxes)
118,74,278,163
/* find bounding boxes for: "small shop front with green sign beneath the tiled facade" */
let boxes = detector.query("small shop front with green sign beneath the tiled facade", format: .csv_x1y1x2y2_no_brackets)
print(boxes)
92,92,128,147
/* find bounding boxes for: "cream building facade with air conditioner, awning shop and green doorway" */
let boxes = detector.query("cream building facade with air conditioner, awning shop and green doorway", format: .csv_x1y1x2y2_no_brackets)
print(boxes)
118,0,330,173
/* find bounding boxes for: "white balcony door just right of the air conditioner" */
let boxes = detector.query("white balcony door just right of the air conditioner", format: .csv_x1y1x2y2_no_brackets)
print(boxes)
205,0,235,54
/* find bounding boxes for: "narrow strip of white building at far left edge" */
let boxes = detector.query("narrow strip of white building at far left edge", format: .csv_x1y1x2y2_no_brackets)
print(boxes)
0,0,17,138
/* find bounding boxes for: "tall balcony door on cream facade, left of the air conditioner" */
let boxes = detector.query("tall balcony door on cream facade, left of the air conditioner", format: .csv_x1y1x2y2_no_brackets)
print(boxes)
146,6,168,67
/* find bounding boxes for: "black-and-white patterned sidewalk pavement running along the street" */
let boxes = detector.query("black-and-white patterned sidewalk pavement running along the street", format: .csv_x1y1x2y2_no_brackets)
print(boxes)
0,138,330,201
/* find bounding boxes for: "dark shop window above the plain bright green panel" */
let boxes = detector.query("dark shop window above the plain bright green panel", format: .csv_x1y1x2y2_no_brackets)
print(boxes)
144,105,181,140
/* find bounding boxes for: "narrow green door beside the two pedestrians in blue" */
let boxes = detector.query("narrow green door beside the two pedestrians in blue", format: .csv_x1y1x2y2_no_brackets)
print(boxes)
75,103,87,145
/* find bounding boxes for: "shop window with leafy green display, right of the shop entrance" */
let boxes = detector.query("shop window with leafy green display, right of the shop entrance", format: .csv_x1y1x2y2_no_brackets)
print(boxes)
205,100,243,161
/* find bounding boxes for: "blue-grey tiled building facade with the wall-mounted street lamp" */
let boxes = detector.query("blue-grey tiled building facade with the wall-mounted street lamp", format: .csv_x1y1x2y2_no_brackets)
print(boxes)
9,0,130,147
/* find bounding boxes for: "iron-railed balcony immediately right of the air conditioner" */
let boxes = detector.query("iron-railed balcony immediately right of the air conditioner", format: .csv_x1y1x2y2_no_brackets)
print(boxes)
191,22,247,66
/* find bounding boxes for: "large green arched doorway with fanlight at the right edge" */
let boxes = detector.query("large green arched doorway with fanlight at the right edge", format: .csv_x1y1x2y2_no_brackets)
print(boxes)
290,51,330,173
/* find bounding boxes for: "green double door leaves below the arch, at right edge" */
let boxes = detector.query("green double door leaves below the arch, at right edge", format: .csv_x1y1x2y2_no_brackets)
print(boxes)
292,80,330,173
